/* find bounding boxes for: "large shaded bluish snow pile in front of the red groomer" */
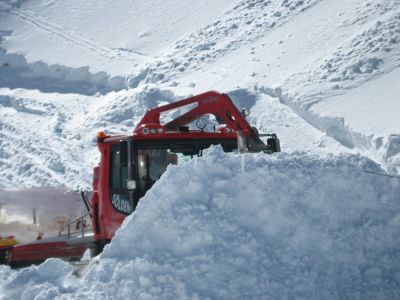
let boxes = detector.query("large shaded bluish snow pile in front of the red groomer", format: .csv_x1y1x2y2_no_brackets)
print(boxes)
1,147,400,299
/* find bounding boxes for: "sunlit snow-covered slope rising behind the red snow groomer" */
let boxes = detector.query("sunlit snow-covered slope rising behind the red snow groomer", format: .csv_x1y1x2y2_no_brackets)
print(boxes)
0,0,400,187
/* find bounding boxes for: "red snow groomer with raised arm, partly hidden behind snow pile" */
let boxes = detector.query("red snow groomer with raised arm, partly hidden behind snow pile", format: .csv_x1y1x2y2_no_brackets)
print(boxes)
7,91,280,266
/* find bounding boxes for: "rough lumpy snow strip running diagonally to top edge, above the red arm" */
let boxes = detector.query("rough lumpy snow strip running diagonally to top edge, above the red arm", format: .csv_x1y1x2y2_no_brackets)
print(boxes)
123,0,321,87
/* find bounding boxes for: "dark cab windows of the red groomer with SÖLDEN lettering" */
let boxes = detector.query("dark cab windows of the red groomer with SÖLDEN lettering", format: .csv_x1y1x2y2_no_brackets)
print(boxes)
109,139,237,214
